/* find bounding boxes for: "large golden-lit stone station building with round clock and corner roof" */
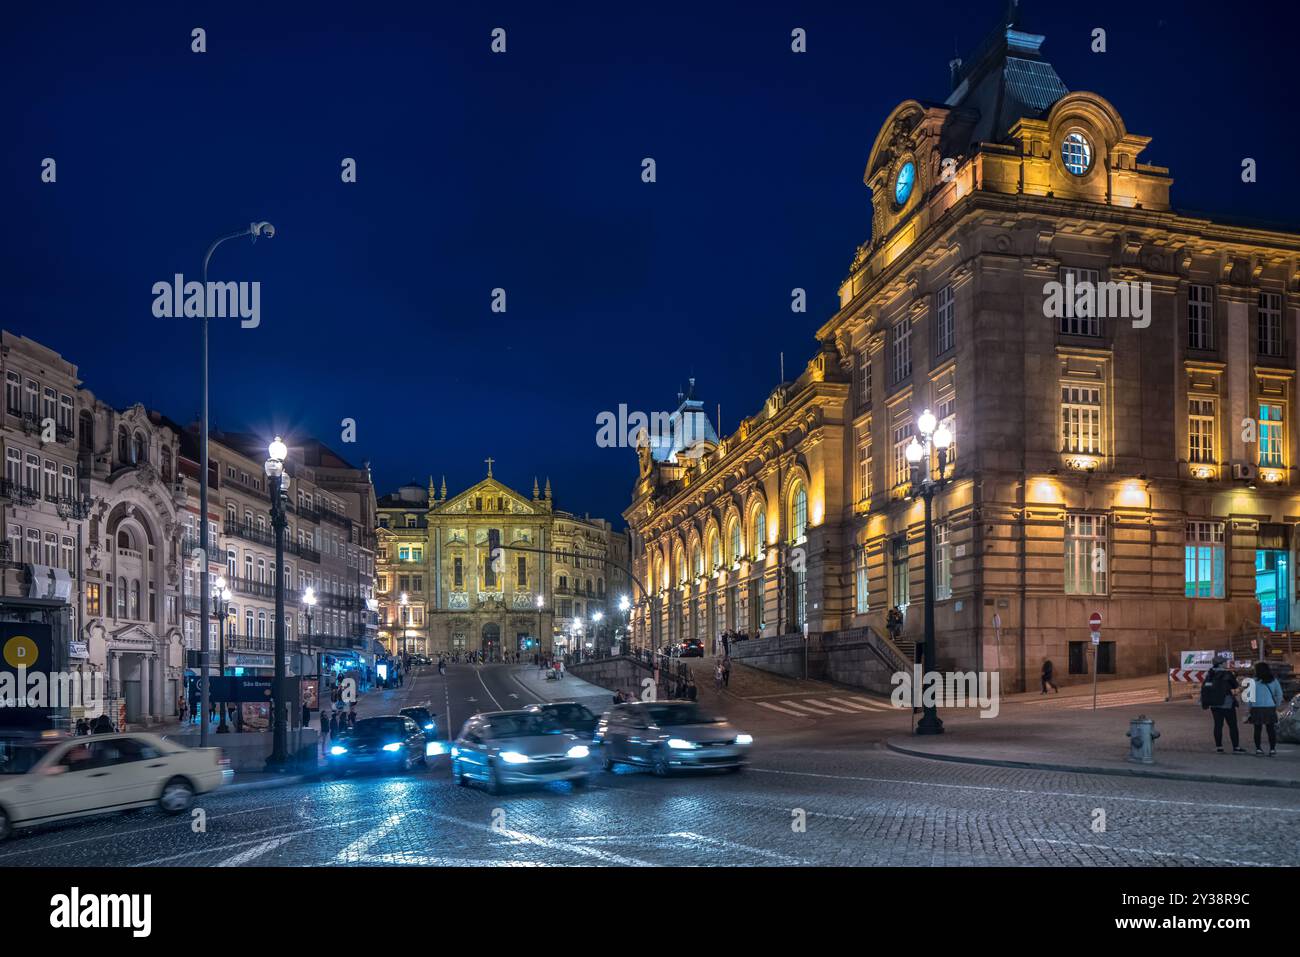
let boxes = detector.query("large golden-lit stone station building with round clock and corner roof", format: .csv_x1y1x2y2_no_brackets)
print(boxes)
625,9,1300,688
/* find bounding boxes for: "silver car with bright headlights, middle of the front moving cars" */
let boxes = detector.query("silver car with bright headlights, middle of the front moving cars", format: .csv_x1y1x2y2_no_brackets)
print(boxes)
451,711,592,794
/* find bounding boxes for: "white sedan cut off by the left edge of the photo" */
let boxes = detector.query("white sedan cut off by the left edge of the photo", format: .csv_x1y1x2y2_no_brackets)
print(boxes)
0,733,233,840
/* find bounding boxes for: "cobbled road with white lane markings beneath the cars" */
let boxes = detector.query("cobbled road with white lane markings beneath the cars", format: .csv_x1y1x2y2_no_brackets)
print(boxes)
0,664,1300,867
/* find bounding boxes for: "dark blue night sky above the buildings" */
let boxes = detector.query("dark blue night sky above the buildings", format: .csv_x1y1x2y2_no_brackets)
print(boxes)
0,0,1300,519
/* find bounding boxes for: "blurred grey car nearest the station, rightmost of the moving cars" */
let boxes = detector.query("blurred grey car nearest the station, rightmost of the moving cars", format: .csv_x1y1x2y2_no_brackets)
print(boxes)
597,701,754,775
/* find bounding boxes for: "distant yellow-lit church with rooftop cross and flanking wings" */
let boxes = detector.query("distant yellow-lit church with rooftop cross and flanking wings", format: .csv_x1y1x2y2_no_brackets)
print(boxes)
377,462,627,655
